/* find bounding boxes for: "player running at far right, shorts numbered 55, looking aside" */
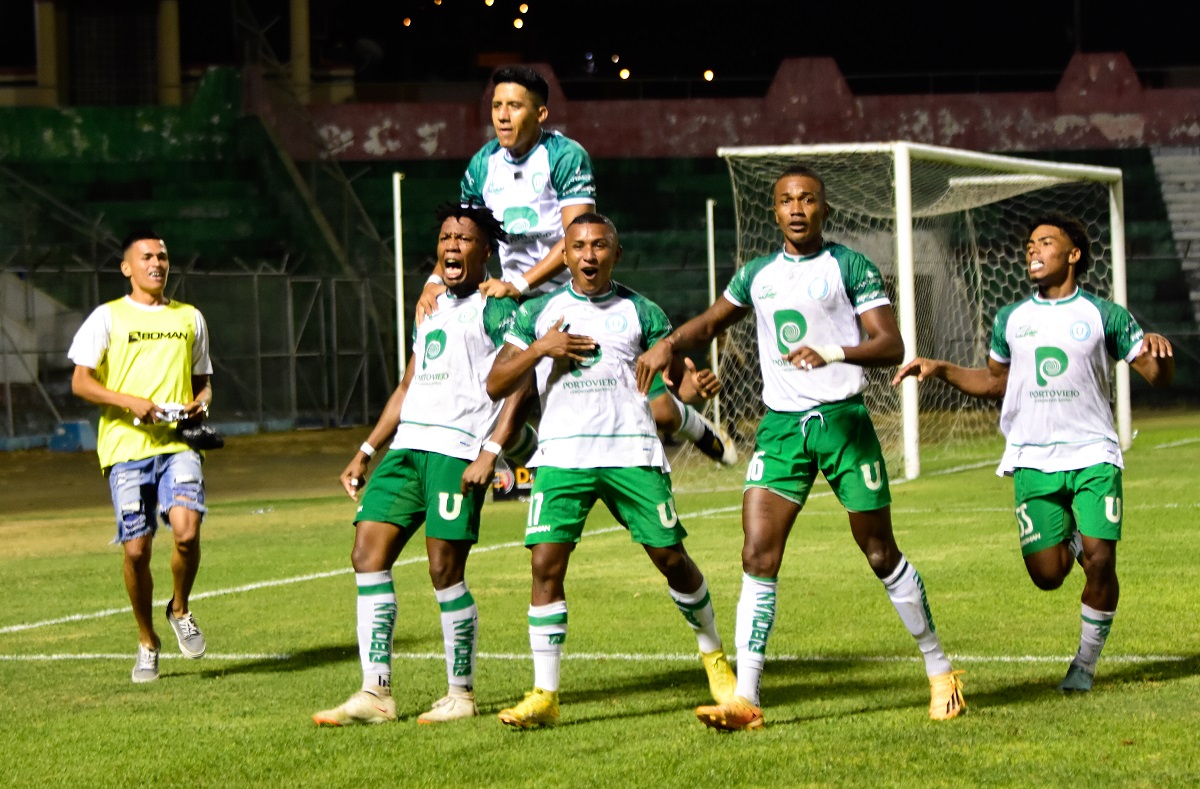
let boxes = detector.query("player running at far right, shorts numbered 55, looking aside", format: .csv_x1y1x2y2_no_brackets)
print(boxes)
893,212,1175,691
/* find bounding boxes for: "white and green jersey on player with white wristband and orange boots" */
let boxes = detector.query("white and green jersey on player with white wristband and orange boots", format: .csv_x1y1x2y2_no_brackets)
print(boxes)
725,242,890,411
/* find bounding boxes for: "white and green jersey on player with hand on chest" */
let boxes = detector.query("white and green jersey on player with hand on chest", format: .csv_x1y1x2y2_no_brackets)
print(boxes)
504,283,671,471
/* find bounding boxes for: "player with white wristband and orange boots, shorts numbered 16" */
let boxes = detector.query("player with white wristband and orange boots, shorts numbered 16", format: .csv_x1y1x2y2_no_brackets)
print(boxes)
637,165,964,730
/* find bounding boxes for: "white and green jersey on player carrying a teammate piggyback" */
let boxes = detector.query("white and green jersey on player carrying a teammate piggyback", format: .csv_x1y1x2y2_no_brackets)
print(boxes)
391,291,517,460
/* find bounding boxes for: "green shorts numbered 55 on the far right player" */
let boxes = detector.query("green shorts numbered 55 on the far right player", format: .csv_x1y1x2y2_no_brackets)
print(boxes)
1013,463,1122,556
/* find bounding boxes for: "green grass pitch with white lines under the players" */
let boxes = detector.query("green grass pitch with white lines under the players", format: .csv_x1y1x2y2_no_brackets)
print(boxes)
0,415,1200,787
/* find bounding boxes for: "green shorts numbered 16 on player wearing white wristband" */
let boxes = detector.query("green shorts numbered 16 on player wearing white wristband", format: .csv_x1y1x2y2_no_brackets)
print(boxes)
745,396,892,512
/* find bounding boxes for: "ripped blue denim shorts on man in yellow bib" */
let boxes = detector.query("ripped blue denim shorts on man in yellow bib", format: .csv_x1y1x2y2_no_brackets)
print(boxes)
108,450,208,543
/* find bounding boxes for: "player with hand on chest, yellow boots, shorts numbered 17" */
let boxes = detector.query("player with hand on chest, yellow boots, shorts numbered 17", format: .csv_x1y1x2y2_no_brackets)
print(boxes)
487,212,734,728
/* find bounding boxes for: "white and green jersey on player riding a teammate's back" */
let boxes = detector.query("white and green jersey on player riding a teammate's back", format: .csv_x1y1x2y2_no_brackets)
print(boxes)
460,130,596,293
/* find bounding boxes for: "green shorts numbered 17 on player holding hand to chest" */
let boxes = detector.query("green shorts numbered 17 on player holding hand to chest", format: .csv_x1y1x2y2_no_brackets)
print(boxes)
526,466,688,548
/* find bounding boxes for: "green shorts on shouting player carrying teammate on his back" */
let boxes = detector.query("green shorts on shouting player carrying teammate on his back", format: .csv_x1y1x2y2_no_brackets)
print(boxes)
354,450,486,542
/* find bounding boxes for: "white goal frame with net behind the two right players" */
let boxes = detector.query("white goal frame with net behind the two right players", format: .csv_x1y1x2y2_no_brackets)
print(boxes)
718,141,1130,478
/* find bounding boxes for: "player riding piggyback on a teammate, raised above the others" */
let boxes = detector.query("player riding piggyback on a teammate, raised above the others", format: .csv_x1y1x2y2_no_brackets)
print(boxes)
418,66,737,465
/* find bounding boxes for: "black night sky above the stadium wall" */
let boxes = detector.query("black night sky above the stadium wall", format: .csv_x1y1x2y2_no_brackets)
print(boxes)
0,0,1200,92
